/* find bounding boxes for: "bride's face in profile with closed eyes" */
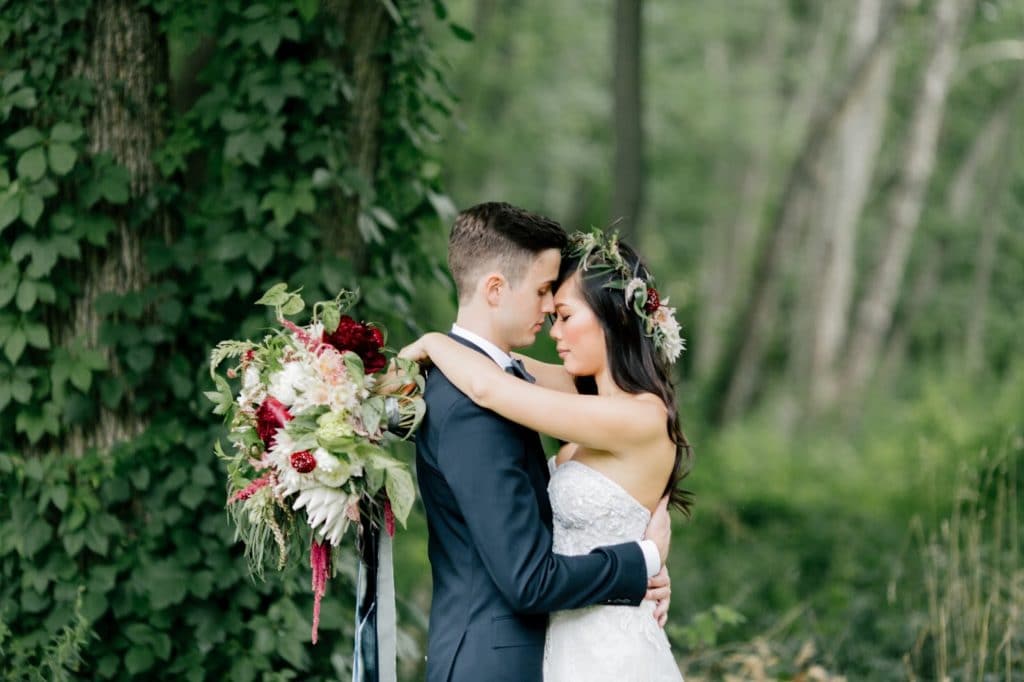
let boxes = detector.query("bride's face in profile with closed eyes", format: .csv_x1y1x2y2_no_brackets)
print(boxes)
551,273,607,377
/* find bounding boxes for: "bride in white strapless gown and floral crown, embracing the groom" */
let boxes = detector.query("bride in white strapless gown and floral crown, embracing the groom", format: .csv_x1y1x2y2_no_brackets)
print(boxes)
400,232,691,682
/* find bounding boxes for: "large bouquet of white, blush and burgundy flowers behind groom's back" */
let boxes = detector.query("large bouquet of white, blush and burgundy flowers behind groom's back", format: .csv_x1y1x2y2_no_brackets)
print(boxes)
207,284,425,643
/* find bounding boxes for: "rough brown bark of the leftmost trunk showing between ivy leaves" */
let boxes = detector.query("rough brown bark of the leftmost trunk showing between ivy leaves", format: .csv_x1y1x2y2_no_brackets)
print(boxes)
58,0,171,456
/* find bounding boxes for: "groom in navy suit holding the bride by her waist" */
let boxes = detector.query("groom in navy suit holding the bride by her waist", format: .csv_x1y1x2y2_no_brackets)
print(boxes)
416,203,669,682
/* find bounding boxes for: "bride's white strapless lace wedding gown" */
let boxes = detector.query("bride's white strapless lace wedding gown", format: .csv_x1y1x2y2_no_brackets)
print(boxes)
544,460,683,682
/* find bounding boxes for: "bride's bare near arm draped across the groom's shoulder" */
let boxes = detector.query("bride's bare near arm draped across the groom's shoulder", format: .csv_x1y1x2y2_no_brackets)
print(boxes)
399,333,665,453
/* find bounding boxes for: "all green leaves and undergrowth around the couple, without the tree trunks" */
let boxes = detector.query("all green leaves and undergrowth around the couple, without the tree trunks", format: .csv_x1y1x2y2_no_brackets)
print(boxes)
0,0,1024,680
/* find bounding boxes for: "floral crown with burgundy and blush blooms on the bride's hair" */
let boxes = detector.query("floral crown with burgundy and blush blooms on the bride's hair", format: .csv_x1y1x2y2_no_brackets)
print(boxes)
569,229,686,365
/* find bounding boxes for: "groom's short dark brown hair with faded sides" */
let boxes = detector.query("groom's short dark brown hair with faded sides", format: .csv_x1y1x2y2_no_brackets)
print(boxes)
449,202,568,302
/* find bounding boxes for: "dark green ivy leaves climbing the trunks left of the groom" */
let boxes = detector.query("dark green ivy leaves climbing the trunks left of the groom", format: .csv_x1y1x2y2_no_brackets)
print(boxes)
0,0,451,680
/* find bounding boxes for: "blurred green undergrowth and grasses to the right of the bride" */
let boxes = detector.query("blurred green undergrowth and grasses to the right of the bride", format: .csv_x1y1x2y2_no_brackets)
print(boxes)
669,364,1024,680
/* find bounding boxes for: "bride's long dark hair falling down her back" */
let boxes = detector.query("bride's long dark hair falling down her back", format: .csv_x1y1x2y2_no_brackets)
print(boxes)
555,242,693,516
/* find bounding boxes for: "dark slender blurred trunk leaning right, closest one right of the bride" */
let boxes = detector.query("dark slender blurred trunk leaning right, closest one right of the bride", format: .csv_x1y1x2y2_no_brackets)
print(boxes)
708,3,902,422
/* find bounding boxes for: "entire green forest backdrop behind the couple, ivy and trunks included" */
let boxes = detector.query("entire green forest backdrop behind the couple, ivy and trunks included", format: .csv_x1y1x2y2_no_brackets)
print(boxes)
0,0,1024,681
